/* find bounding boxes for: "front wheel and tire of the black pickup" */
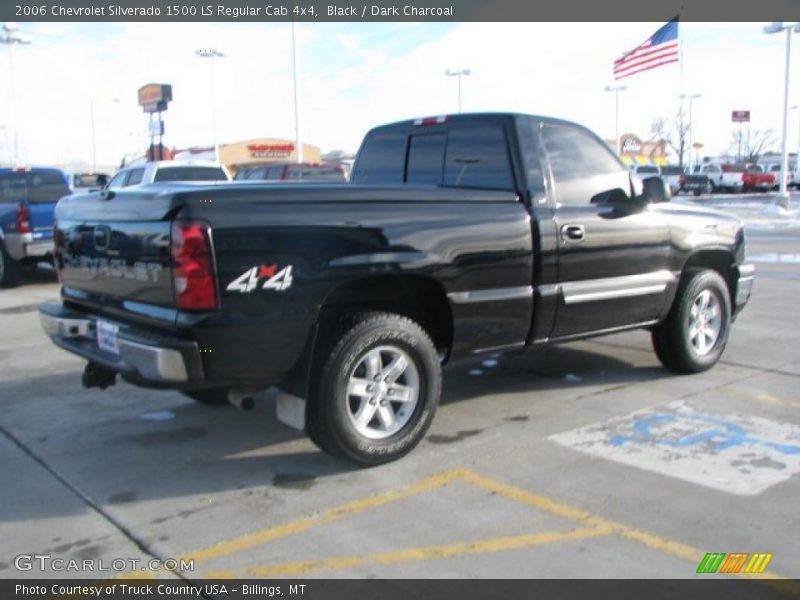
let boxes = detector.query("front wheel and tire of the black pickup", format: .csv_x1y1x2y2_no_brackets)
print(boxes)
652,269,731,373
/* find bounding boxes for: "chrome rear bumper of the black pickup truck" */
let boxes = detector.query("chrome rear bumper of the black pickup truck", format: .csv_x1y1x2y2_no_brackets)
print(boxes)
39,303,204,387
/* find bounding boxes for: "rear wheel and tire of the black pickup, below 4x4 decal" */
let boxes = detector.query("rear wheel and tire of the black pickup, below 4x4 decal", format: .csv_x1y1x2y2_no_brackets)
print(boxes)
306,313,441,466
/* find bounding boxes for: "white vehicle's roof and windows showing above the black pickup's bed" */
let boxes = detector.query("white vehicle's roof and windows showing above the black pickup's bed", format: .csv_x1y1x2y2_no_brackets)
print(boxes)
106,160,231,190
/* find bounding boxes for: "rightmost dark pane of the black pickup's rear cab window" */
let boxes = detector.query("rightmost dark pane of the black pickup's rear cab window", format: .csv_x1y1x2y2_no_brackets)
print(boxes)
444,125,514,190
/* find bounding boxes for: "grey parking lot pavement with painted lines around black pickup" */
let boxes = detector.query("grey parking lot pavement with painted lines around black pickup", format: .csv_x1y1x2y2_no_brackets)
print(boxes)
0,196,800,579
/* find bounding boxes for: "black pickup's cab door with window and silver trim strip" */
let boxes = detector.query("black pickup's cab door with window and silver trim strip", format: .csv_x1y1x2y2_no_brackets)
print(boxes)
540,123,674,338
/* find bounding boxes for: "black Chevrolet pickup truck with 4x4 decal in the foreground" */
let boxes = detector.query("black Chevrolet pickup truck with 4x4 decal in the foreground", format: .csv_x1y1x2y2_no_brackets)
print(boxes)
40,114,754,464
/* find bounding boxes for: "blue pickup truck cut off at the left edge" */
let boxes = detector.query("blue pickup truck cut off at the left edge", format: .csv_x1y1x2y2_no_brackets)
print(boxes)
0,167,70,287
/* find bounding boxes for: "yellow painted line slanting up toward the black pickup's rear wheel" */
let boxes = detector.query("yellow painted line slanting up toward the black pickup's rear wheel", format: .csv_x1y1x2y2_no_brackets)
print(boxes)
184,471,456,562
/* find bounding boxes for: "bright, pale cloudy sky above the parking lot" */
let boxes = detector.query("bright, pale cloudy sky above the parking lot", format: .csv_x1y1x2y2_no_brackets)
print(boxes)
0,22,800,165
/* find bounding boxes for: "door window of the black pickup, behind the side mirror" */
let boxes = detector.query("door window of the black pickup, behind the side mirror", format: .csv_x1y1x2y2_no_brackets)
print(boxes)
542,124,630,206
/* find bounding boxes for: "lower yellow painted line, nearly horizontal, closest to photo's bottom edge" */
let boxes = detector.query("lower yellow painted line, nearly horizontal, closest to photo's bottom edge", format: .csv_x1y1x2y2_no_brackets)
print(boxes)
248,527,610,577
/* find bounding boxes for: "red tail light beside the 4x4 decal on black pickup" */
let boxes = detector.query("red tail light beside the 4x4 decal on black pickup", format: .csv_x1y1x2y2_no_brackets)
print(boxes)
171,222,217,310
